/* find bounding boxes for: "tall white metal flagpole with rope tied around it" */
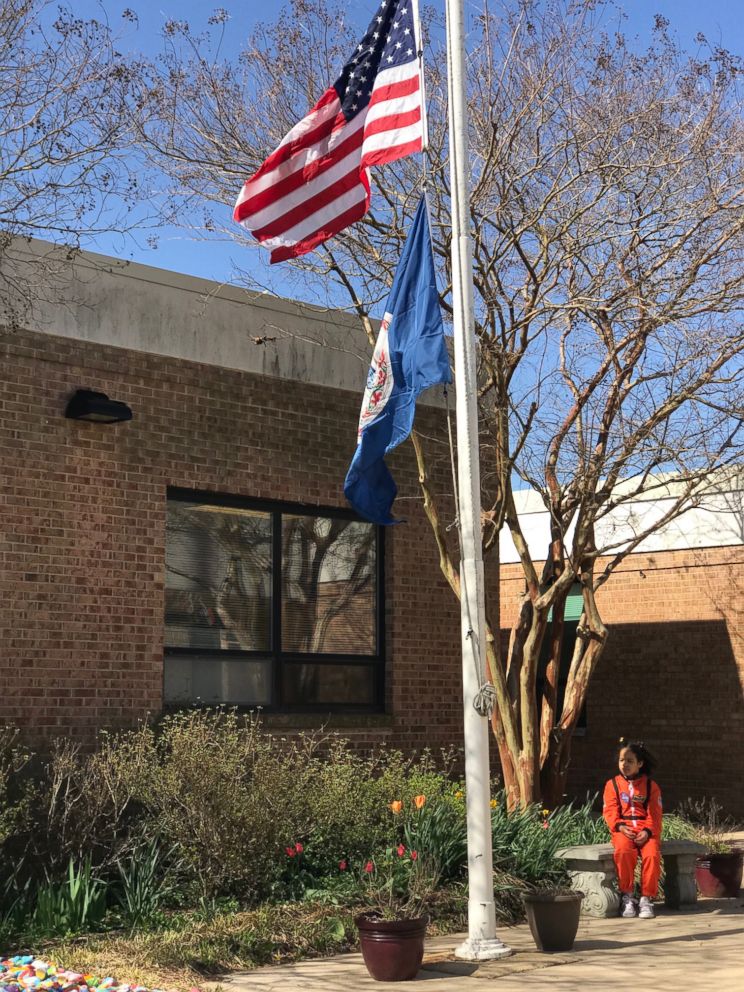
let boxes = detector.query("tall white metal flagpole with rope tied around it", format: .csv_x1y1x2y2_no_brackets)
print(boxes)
446,0,512,961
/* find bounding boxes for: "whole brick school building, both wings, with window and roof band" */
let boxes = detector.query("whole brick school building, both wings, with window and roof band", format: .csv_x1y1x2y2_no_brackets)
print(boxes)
0,245,744,814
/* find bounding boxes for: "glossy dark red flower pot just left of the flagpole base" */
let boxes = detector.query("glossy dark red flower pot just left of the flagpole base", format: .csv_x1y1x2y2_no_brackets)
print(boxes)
354,916,429,982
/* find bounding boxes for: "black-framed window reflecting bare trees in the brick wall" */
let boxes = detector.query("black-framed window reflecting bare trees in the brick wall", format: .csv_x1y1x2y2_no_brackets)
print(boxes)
164,490,384,711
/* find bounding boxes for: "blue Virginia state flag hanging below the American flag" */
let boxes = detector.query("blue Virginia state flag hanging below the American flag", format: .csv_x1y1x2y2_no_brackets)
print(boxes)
344,197,452,524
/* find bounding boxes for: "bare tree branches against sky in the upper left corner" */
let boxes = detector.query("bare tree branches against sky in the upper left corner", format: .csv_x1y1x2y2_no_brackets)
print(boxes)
0,0,147,326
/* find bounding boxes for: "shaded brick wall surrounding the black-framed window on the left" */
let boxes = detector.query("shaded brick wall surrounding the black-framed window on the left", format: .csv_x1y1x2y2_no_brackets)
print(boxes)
0,334,460,748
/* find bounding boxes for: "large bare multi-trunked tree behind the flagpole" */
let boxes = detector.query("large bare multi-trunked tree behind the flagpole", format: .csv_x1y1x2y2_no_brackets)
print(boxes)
131,0,744,804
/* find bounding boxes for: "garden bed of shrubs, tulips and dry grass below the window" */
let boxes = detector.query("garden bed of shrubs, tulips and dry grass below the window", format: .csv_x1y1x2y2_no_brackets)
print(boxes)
0,710,728,992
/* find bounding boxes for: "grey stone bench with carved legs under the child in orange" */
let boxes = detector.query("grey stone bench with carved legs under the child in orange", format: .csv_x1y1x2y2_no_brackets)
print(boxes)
556,840,705,917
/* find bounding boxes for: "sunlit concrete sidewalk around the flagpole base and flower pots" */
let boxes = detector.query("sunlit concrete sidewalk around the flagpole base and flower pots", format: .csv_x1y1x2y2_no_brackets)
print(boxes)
214,898,744,992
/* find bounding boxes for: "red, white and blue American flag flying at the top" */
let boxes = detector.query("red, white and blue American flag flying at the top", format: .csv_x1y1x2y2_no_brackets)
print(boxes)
233,0,425,262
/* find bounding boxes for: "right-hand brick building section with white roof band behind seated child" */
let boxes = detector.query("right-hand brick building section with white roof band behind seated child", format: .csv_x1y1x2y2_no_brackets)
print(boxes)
501,491,744,816
